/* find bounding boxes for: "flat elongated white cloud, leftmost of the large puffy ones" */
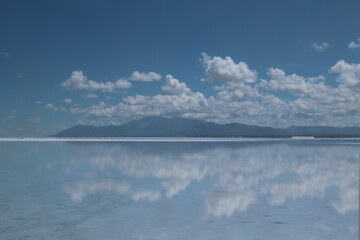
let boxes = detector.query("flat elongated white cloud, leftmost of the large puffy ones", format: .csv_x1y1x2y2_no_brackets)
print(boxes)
61,71,131,92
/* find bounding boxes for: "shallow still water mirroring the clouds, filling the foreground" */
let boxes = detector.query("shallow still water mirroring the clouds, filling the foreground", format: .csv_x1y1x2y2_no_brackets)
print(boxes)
0,140,360,240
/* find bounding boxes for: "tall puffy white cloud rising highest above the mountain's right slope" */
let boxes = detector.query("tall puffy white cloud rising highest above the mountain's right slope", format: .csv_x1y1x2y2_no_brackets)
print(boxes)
201,53,257,83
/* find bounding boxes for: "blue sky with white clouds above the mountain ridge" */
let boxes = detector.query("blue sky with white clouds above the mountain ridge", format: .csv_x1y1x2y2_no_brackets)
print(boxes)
0,0,360,136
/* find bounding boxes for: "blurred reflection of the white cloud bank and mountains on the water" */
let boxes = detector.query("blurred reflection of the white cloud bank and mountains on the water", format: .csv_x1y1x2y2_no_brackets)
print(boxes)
58,141,359,217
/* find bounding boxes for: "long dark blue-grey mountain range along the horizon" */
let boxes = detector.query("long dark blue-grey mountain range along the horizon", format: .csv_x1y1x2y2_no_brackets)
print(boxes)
53,117,360,137
